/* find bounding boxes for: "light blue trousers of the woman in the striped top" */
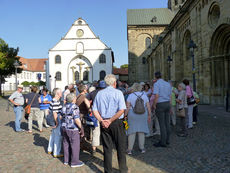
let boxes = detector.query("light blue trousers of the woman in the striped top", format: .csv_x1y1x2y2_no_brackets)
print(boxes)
48,122,62,156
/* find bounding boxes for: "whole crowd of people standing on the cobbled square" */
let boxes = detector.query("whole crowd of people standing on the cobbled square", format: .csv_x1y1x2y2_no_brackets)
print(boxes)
9,72,198,173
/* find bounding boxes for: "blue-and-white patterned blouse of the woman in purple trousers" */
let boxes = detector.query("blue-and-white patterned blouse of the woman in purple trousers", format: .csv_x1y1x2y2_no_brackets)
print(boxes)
61,103,76,129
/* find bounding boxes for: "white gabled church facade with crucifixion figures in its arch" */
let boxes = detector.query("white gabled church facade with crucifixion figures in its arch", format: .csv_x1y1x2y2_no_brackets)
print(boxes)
47,18,114,90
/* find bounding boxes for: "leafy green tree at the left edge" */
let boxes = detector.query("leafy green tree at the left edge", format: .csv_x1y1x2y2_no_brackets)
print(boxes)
0,38,22,95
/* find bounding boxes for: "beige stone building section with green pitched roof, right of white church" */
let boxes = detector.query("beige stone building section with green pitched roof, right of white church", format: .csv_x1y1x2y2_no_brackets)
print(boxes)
127,8,173,83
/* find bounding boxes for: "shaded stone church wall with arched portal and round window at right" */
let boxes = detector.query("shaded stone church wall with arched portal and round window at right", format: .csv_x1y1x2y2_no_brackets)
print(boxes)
127,0,230,105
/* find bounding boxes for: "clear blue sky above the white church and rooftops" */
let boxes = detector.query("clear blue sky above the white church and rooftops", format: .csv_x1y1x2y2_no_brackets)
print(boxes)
0,0,168,67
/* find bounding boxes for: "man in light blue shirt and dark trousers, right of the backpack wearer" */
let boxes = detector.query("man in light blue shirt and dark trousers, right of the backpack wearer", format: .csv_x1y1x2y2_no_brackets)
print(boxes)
153,72,172,147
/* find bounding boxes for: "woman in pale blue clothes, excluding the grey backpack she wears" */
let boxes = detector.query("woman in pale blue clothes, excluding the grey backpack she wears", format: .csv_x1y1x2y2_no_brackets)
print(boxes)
125,83,151,154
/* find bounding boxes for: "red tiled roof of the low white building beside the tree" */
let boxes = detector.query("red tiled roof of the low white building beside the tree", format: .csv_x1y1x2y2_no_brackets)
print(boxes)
19,57,48,72
